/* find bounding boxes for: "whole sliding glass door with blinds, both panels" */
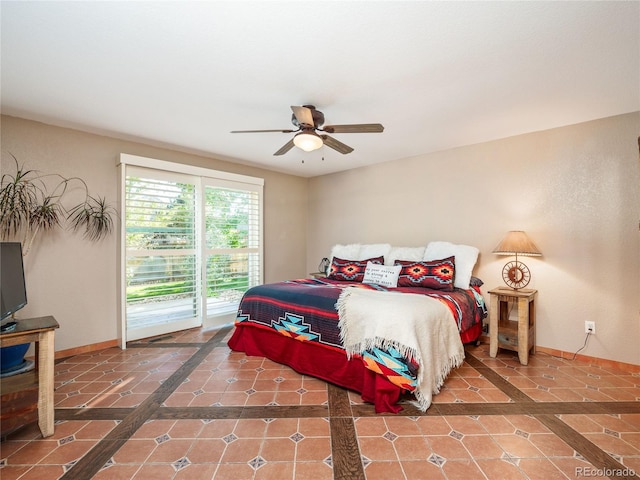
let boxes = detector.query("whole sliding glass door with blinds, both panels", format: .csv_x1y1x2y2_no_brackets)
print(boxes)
122,157,262,341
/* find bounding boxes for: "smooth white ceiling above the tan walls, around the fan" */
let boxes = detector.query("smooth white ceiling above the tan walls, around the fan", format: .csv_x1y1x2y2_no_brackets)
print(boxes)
0,1,640,177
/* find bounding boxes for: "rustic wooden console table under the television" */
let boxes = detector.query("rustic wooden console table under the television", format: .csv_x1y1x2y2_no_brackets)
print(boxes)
0,316,60,437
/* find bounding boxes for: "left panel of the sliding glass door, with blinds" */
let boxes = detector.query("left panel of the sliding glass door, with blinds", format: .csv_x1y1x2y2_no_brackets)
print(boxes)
125,170,202,340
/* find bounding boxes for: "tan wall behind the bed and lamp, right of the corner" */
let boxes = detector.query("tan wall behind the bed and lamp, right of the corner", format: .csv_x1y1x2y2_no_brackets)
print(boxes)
307,113,640,364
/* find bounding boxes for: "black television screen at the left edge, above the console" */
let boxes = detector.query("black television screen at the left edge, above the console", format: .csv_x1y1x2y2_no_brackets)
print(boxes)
0,242,27,320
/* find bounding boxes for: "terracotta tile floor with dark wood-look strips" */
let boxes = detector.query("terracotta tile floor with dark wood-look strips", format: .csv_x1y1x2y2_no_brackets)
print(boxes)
0,329,640,480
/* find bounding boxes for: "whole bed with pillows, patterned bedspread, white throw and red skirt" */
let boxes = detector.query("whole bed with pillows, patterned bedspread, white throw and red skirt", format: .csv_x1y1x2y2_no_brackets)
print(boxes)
228,242,486,413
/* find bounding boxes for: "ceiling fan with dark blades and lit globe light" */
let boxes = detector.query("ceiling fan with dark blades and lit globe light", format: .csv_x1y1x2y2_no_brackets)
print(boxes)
231,105,384,155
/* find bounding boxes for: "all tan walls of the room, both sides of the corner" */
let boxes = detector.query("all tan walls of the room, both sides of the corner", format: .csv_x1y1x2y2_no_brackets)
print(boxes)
5,113,640,364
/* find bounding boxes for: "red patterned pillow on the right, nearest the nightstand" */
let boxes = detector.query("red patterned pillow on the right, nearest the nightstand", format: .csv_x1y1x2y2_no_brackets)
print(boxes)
396,257,456,290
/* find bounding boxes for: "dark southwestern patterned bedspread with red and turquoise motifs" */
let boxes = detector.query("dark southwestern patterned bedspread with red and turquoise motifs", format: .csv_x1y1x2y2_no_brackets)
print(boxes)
229,279,486,408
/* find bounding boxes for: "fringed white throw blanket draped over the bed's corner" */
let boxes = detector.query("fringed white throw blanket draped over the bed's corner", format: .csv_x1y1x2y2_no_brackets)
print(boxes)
336,287,464,412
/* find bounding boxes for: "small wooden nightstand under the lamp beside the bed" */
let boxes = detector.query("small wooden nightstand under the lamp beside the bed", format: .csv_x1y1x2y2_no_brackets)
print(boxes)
489,287,538,365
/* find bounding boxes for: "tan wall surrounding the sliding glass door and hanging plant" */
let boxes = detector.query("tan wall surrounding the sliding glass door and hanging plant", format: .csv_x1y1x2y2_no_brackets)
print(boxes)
0,116,308,350
